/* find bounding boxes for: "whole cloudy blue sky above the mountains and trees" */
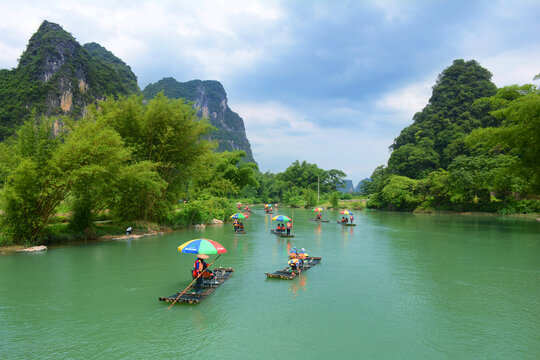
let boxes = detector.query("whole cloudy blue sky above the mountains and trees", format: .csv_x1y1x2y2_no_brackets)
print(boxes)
0,0,540,185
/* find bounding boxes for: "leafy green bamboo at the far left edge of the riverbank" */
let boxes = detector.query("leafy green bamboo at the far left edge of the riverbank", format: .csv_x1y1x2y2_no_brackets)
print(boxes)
0,118,62,244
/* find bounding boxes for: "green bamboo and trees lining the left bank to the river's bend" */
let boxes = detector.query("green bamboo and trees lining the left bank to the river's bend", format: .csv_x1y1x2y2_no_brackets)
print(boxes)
0,94,345,245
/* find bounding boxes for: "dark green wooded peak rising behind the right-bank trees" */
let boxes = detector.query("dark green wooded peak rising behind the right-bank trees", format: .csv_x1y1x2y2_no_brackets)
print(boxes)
388,60,498,179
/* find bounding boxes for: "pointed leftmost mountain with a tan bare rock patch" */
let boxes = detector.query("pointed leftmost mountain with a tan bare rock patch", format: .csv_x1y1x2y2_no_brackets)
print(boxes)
0,21,140,140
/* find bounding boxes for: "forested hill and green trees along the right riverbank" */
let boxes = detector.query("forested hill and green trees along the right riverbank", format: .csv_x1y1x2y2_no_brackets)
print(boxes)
361,60,540,214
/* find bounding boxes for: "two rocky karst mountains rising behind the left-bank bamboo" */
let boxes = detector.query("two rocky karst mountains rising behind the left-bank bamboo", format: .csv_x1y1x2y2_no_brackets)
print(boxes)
0,21,254,162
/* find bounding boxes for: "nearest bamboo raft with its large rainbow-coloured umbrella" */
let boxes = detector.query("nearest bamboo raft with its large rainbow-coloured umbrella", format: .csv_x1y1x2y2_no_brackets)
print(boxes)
159,238,234,308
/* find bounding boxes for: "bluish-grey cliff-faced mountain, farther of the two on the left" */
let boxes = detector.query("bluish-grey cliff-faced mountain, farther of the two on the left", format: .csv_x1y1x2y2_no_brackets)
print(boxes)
143,77,255,162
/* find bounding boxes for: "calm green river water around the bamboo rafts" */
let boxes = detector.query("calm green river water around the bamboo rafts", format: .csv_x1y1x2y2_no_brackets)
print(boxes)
0,208,540,360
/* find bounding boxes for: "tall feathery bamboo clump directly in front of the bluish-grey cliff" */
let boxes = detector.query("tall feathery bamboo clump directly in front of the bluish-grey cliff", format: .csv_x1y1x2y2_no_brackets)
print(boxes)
91,93,215,220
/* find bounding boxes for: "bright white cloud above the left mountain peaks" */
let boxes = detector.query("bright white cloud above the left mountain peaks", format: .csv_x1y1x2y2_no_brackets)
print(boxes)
0,0,294,86
